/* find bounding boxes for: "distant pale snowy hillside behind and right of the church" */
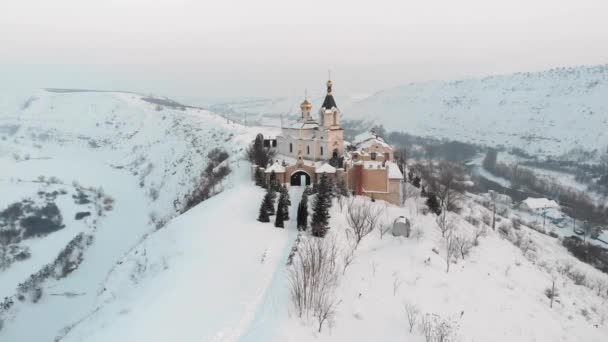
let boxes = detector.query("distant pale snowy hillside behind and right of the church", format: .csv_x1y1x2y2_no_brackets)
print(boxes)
344,65,608,155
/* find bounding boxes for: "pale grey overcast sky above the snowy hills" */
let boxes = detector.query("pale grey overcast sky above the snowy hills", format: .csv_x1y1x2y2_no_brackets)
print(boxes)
0,0,608,97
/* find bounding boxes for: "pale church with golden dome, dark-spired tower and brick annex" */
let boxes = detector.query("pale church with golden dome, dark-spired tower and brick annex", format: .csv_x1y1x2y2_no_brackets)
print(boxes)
255,80,403,205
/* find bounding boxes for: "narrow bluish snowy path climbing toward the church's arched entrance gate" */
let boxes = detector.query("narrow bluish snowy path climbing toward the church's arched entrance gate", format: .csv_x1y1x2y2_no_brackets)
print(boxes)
239,186,304,342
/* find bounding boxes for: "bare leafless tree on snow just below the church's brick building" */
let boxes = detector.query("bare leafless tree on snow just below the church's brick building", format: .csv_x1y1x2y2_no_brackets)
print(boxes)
346,198,384,248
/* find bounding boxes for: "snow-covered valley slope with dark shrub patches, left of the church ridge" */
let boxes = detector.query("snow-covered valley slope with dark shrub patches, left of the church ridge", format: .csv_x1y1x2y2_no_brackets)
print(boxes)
0,90,256,341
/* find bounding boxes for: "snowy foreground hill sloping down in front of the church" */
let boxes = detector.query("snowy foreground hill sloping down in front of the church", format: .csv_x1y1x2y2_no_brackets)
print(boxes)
35,163,608,342
